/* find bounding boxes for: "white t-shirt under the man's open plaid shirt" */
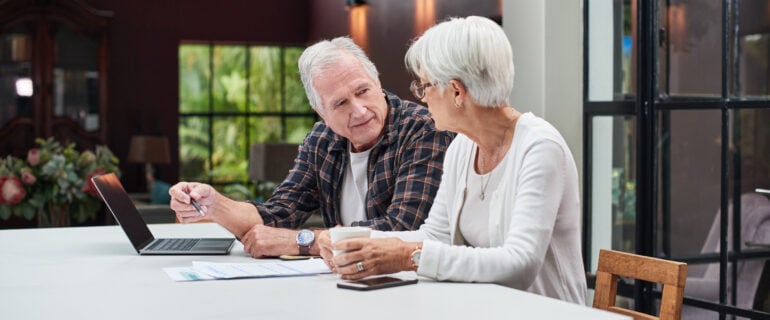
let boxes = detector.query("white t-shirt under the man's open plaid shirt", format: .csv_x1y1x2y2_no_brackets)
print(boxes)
340,143,372,226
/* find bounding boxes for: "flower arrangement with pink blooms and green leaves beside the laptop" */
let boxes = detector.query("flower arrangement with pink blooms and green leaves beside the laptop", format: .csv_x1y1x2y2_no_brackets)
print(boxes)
0,138,119,226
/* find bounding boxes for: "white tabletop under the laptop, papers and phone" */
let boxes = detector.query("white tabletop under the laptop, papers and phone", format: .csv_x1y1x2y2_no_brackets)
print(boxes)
0,223,628,320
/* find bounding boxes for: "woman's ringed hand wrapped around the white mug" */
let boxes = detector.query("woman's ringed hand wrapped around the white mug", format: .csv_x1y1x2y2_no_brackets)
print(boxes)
332,238,417,280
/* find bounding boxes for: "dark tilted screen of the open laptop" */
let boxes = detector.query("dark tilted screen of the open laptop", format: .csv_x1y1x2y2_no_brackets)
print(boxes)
92,173,155,252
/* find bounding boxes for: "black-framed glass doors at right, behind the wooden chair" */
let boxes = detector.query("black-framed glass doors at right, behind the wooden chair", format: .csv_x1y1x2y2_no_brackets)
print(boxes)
584,0,770,319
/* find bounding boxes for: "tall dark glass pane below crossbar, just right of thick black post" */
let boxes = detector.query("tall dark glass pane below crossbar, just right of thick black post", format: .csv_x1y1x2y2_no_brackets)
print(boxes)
656,110,721,256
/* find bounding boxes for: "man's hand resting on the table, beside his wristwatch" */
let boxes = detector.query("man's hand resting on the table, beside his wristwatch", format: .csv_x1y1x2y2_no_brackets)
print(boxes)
241,224,299,258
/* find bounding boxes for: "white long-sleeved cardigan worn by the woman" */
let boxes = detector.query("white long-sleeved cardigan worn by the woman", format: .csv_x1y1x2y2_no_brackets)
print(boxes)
373,113,587,304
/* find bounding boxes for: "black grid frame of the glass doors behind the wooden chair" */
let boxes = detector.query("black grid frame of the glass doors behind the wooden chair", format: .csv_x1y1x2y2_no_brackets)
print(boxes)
583,0,770,319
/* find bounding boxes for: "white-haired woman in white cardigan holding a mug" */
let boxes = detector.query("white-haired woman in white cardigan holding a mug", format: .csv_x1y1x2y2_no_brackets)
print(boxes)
321,17,586,304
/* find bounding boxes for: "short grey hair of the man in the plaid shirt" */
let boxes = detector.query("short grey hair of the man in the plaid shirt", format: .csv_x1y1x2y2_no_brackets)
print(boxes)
297,37,380,114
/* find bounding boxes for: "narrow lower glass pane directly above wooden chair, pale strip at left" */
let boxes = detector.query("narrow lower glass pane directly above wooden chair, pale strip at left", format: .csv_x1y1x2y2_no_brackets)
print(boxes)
591,116,637,270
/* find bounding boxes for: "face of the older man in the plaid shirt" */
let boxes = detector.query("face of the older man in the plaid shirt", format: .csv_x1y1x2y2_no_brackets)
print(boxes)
313,56,388,152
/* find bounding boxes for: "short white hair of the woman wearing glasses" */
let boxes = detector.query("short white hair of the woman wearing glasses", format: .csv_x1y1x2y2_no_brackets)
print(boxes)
404,16,514,107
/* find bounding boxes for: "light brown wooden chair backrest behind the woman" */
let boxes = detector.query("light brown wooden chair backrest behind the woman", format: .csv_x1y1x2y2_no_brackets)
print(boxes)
593,249,687,320
